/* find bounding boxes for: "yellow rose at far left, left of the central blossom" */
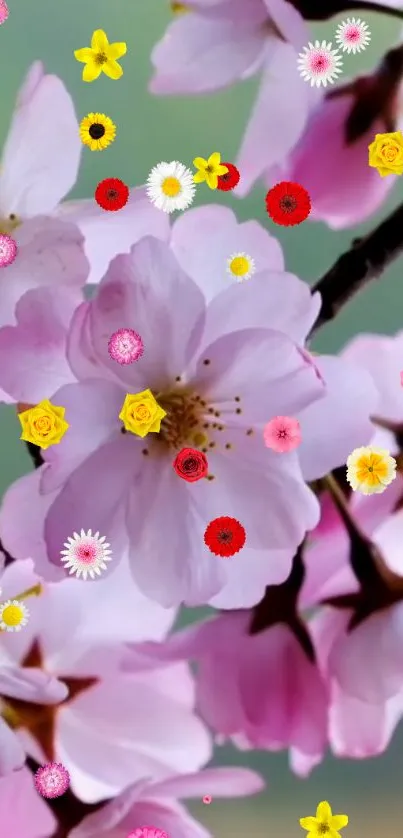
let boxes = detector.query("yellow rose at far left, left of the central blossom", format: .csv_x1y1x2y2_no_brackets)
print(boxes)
18,399,69,450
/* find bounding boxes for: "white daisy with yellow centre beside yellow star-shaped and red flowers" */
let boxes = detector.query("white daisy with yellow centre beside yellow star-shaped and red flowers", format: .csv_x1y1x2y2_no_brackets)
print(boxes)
147,160,196,212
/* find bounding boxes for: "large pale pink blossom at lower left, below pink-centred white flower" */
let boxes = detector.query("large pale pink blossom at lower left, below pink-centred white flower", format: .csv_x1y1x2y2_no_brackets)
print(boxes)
0,560,211,803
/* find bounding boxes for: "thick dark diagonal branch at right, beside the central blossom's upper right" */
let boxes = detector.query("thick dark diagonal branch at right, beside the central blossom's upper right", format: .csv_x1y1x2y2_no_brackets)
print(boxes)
311,204,403,336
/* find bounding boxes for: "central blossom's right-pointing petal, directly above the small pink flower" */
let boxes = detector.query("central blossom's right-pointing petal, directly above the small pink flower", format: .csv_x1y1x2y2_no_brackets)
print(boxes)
195,329,326,428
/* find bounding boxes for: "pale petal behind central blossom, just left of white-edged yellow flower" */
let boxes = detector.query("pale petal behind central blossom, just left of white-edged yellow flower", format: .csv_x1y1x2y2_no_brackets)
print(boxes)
297,355,379,481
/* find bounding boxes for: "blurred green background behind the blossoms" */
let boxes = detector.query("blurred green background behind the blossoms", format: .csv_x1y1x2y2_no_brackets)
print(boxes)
0,0,403,838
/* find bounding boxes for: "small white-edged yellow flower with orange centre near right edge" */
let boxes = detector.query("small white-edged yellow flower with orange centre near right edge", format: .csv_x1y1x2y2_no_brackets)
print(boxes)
347,445,396,495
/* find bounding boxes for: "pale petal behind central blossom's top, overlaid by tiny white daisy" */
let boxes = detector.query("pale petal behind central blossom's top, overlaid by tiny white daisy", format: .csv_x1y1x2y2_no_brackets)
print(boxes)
171,204,287,304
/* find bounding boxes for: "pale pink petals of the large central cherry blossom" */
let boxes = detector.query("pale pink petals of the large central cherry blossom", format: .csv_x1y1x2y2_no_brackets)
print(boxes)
0,239,325,606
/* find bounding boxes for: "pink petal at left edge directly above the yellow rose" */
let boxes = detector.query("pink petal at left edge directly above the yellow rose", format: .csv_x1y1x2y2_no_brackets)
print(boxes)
0,288,81,404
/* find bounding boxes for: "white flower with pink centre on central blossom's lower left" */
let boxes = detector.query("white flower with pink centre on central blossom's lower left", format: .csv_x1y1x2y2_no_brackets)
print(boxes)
60,530,111,580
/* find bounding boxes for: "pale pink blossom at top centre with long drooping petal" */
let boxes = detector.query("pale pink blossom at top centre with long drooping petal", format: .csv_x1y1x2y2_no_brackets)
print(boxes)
150,0,312,192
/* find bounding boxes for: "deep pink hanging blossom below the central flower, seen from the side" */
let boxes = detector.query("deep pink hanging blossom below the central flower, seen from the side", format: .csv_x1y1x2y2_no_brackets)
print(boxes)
124,611,328,776
